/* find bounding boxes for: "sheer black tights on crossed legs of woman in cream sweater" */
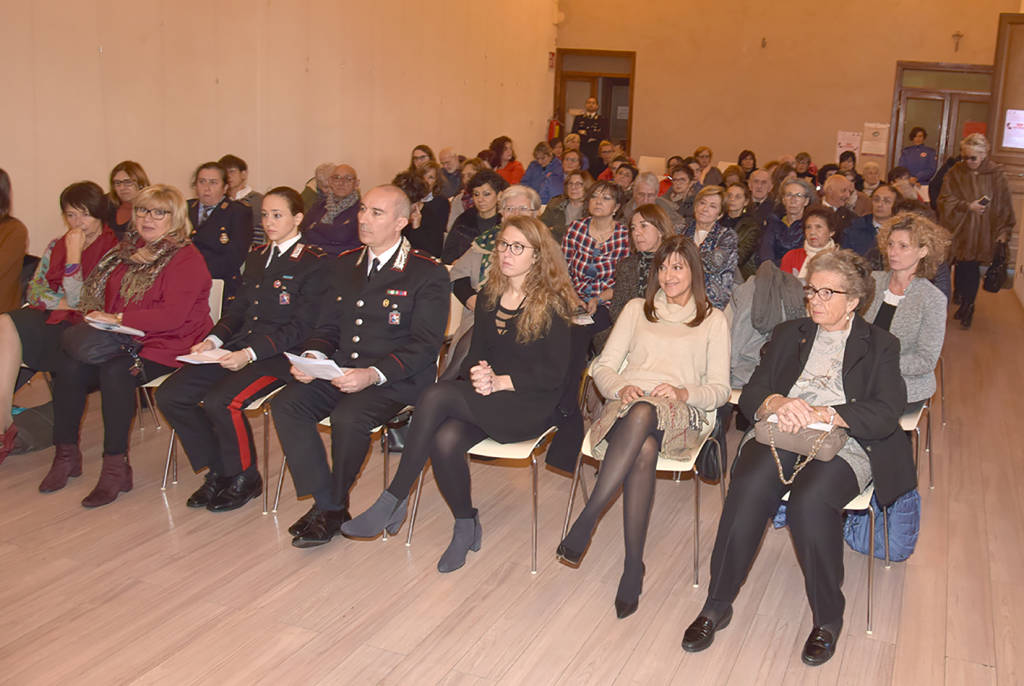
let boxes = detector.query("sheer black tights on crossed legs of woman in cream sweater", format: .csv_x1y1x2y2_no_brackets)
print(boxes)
565,402,664,597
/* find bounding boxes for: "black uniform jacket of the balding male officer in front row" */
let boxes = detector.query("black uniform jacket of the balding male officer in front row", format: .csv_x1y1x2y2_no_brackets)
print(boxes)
302,238,452,404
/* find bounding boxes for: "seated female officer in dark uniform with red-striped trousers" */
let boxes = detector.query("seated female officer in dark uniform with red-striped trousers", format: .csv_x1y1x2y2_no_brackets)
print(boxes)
157,186,333,512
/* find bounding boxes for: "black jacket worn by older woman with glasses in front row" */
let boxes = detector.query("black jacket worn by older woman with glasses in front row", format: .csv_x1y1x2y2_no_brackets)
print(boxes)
739,316,918,507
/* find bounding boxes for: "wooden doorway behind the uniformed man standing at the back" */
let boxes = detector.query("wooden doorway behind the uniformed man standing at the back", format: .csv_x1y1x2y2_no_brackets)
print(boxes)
554,48,636,149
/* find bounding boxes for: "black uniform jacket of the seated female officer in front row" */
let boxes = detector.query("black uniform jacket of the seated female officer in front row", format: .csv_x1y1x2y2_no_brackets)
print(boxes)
210,241,331,359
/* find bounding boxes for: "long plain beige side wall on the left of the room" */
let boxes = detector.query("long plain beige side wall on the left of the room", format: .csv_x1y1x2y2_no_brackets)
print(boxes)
0,0,556,252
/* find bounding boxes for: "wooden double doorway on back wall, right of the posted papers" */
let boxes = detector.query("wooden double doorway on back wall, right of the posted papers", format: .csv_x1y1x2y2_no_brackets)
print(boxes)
888,61,992,169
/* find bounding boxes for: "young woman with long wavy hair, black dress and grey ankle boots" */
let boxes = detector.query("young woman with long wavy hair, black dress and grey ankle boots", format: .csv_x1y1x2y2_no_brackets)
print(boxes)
341,216,577,572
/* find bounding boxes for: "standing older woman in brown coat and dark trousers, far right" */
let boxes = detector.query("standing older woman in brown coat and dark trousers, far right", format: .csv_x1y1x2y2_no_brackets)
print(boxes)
939,133,1017,329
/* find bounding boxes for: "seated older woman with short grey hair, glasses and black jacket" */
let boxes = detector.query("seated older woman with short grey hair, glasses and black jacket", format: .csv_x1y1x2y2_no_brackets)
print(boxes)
683,250,916,666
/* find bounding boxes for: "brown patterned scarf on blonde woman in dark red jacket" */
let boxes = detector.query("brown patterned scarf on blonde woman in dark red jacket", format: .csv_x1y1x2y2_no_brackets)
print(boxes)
76,229,189,313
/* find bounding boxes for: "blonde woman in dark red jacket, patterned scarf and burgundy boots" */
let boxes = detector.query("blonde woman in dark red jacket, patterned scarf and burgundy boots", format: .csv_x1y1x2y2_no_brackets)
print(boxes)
39,184,213,507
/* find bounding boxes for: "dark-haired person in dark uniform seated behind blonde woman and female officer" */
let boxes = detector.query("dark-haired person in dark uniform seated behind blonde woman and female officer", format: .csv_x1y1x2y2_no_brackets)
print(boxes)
188,162,253,302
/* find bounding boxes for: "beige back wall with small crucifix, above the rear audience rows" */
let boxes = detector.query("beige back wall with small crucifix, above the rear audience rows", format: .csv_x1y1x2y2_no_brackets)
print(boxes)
558,0,1021,166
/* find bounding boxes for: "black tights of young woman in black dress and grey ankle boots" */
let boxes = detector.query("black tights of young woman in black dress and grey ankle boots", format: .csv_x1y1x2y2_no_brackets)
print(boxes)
387,381,487,519
